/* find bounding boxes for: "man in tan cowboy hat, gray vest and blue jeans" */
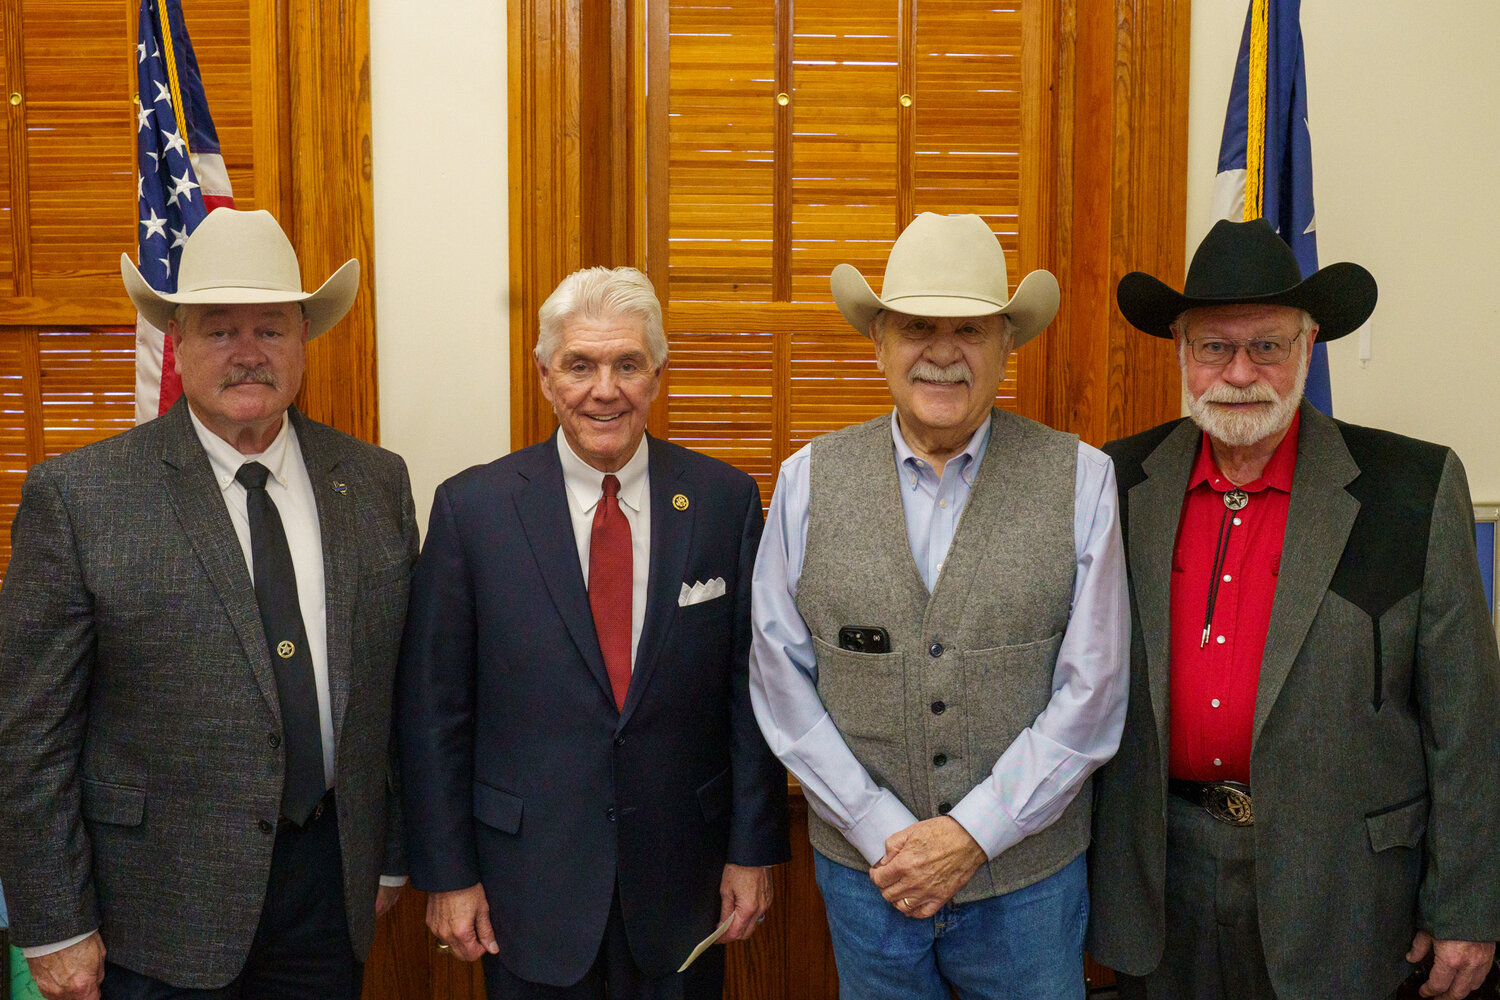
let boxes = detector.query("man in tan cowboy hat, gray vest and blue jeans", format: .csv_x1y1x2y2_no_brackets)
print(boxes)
750,214,1128,1000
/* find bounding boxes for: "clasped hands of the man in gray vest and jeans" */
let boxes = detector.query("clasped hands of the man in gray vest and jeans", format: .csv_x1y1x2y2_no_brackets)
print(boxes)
870,816,989,918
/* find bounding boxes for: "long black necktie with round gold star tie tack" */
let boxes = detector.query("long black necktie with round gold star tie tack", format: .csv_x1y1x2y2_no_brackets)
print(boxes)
234,462,329,825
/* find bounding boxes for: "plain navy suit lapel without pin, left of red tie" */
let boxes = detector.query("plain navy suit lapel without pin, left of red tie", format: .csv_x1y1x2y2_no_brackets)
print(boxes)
515,432,615,705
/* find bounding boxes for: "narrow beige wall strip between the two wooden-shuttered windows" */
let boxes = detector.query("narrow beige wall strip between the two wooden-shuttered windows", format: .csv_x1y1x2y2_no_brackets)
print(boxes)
371,0,510,531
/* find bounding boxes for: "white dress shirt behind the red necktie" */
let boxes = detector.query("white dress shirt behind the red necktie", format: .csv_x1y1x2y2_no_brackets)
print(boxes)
558,430,651,670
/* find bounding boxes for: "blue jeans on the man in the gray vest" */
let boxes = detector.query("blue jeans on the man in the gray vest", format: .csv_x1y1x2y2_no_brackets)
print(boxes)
813,852,1089,1000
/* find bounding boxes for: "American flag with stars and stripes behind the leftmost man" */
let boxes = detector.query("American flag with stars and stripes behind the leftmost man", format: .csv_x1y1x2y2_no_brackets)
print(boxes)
135,0,234,423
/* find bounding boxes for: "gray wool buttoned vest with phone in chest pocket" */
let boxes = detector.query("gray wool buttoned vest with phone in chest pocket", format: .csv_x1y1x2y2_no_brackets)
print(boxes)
797,409,1089,903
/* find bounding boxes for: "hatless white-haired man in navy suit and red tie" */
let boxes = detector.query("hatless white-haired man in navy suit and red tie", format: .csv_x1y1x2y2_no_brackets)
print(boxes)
398,267,789,1000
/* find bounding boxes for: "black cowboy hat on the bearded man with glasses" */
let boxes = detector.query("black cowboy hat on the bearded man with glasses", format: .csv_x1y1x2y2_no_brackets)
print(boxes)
1115,219,1376,342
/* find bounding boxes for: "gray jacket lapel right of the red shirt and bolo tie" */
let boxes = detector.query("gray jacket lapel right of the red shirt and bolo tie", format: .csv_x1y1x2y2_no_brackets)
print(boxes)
1251,402,1359,748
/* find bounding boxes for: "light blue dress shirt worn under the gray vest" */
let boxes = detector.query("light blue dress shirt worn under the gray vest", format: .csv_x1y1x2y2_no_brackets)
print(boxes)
750,412,1130,865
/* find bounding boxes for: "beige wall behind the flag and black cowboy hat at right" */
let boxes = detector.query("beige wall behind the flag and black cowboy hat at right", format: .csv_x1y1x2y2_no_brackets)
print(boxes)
1187,0,1500,502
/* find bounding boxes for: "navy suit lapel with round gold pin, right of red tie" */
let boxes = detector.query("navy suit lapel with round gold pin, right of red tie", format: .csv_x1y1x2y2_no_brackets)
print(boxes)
620,438,690,726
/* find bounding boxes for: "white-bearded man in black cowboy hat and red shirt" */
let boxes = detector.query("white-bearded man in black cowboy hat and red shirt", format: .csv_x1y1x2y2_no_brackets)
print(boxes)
1089,220,1500,1000
